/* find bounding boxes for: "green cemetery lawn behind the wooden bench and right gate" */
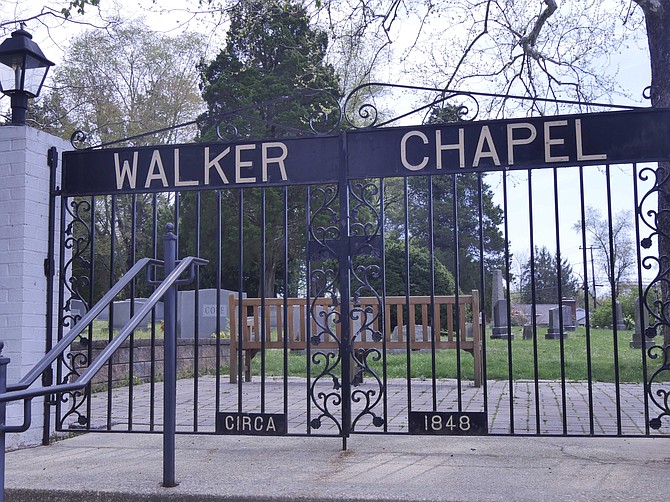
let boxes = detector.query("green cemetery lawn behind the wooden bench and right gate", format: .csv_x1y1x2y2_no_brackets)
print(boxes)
252,328,659,382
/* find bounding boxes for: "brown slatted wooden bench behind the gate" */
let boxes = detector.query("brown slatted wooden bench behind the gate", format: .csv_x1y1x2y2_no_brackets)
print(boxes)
229,290,483,387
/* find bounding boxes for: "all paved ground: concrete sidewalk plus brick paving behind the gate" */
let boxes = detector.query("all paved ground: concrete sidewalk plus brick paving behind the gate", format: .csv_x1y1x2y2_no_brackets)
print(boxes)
6,377,670,502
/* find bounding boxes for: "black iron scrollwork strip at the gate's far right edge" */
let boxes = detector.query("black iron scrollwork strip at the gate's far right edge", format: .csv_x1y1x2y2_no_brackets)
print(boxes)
638,166,670,429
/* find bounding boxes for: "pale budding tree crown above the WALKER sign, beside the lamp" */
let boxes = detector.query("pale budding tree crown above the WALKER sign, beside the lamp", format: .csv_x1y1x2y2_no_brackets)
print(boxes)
43,20,204,145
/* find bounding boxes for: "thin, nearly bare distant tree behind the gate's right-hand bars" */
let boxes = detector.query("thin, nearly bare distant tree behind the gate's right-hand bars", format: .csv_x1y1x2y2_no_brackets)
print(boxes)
573,207,636,298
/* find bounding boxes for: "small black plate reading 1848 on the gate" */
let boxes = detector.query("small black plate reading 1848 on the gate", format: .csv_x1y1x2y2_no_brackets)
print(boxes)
409,411,489,436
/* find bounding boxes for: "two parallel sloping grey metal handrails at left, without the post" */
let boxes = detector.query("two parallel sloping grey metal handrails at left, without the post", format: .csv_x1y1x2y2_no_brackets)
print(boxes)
0,256,207,403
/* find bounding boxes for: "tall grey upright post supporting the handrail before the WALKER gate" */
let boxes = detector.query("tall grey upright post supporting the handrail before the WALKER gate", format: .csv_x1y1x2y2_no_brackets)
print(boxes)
163,224,179,487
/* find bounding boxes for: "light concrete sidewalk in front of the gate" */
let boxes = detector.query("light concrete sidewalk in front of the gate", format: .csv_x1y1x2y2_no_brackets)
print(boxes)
6,433,670,502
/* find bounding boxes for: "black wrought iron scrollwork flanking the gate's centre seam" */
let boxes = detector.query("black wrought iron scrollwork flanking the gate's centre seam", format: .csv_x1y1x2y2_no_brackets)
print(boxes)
308,181,385,433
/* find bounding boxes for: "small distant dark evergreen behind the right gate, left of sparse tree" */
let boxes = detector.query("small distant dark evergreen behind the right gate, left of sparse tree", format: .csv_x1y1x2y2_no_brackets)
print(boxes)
520,247,579,304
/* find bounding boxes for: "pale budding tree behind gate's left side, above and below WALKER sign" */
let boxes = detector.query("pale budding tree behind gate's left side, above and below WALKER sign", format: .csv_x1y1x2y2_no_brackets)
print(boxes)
38,20,203,298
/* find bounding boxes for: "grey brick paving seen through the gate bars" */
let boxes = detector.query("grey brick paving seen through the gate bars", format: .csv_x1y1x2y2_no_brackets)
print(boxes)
63,376,670,435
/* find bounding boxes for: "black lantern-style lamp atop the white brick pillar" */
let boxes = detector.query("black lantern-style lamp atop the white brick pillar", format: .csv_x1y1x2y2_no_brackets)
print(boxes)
0,26,54,125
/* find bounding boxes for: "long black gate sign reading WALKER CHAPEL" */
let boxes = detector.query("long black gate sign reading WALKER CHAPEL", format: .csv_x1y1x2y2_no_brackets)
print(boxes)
62,109,670,195
